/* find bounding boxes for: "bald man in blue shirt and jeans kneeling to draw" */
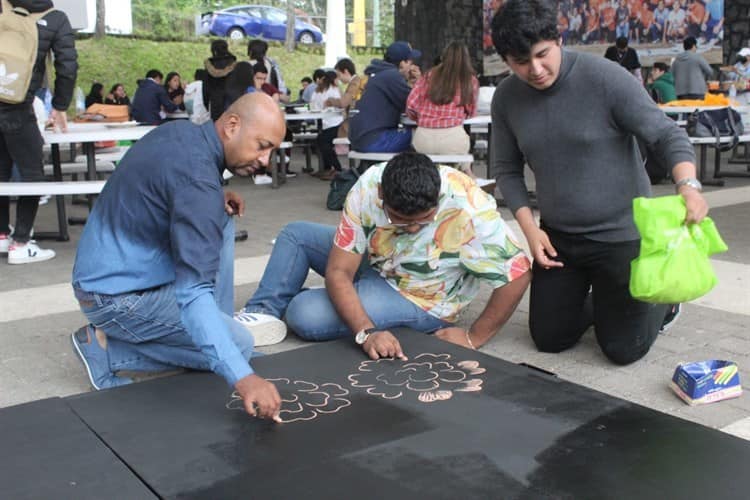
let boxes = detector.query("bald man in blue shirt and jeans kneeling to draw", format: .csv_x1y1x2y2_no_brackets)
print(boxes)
72,93,285,418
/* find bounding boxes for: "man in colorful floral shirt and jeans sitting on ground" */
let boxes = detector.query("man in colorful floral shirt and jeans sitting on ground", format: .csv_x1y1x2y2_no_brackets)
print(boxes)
235,153,531,359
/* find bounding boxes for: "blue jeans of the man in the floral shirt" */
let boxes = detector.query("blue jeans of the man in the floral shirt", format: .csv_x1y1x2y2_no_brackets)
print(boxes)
245,222,450,340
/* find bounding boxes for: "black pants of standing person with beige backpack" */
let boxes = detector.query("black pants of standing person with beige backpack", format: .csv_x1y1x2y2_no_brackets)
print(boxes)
0,105,44,243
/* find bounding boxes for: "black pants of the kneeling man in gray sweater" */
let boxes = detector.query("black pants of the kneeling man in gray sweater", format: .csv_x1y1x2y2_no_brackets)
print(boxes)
529,228,668,365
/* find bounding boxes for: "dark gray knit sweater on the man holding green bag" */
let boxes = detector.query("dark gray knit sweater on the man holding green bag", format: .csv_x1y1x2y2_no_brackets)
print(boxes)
492,50,695,241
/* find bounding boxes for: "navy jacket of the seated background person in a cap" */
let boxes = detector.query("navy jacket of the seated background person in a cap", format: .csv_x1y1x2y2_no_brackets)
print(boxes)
349,59,411,151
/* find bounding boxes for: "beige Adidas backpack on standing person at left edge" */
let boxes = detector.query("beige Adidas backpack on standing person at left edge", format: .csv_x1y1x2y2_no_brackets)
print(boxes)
0,0,52,104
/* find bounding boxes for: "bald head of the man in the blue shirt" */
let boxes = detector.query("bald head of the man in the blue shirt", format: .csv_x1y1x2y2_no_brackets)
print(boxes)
216,92,286,175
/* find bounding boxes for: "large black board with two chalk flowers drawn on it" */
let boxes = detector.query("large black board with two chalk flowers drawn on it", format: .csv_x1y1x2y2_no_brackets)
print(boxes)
69,331,750,499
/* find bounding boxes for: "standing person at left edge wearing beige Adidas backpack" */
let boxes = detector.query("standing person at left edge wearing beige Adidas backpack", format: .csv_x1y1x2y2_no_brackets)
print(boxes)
0,0,78,264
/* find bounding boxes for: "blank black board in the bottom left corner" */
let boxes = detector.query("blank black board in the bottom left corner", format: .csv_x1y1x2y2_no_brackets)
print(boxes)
0,398,156,500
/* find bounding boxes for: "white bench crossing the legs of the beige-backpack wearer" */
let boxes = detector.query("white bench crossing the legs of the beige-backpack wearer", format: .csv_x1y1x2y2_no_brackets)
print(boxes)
0,181,106,241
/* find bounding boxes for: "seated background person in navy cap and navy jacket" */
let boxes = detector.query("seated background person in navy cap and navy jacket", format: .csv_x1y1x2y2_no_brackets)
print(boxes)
349,42,422,153
